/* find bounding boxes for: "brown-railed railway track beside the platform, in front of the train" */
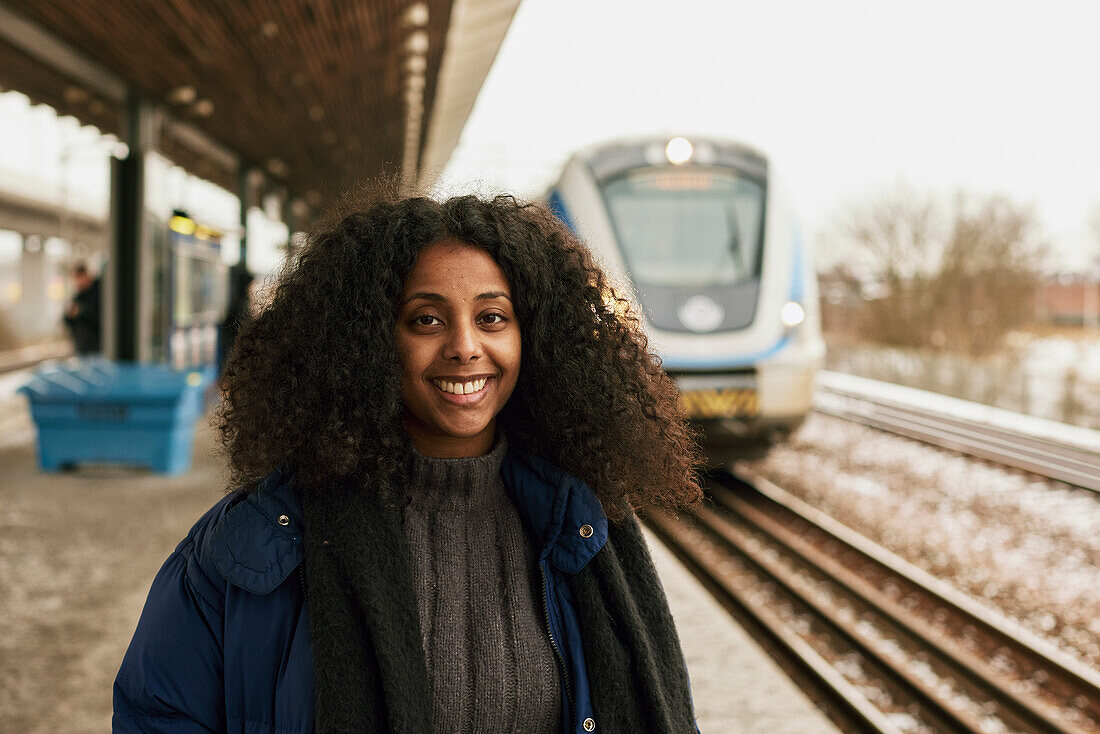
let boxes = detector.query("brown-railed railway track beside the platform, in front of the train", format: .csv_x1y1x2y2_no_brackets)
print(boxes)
646,473,1100,734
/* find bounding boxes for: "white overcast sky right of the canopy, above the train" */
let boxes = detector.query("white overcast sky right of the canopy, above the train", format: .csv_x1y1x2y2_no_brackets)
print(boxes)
442,0,1100,266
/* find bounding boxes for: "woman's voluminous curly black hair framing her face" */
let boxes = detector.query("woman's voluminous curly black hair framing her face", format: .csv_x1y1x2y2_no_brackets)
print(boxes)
216,196,702,519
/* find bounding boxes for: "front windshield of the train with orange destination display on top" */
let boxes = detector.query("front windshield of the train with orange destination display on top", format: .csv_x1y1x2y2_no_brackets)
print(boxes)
604,166,765,287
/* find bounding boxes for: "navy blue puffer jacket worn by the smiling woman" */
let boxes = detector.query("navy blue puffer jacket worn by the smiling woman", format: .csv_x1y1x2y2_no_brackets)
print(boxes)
113,452,608,734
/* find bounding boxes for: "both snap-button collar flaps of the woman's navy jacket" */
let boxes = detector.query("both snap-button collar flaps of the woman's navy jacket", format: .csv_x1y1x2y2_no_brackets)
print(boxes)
205,450,607,594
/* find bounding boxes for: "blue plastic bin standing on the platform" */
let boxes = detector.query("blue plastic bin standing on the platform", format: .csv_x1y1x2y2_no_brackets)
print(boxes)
19,359,215,474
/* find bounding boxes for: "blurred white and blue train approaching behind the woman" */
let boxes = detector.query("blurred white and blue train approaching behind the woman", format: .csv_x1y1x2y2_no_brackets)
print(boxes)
543,135,825,442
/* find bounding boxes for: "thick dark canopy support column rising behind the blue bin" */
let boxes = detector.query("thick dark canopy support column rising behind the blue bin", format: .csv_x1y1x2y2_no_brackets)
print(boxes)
100,92,157,362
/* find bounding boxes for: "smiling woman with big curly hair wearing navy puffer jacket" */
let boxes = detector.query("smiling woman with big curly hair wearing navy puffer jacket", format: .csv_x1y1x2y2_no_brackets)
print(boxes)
113,191,702,734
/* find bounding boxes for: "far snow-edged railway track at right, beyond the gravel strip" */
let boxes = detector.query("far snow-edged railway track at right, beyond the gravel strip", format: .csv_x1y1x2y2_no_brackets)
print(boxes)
814,372,1100,492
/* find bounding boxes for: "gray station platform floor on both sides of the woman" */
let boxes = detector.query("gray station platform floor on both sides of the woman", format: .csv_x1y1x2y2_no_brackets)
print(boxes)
0,385,836,734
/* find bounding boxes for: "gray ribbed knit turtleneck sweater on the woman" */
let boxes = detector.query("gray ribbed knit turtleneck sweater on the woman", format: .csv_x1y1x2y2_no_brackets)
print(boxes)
403,437,561,734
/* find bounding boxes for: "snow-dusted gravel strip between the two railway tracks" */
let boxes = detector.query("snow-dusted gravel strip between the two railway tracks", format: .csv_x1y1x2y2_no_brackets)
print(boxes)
745,414,1100,667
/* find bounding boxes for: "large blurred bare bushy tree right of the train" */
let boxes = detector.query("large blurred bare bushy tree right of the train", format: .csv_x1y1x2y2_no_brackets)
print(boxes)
838,186,1045,354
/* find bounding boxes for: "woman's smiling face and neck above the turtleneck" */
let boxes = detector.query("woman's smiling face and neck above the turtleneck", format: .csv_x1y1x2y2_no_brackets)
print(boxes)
397,239,520,457
